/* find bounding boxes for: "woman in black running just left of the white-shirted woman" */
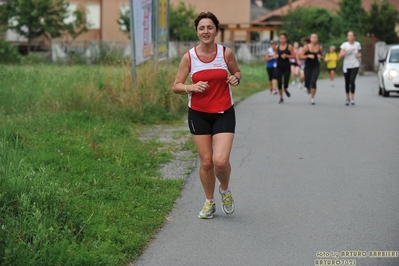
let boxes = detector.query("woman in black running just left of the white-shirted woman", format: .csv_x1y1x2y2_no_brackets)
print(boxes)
300,33,323,105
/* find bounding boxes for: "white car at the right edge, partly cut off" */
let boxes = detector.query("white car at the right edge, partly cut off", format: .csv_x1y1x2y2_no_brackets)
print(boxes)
378,45,399,97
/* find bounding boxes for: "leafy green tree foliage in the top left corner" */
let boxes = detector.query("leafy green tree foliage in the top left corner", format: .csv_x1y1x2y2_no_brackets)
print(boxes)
3,0,88,52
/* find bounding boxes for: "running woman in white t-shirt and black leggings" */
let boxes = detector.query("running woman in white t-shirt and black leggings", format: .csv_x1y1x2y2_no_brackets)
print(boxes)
338,31,362,106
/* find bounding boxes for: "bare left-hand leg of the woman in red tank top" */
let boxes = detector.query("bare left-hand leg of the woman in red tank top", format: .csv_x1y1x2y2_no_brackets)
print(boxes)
193,135,216,200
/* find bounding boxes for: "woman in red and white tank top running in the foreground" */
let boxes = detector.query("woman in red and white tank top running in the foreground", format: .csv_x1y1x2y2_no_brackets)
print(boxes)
173,12,241,219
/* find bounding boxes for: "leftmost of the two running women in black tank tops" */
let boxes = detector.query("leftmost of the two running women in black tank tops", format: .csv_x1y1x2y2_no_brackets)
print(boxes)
274,32,295,103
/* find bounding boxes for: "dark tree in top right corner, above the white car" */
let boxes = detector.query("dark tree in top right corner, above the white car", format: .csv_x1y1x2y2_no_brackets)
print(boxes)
364,1,398,44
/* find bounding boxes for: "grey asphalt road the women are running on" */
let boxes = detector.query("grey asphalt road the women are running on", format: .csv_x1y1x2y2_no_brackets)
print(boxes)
133,76,399,266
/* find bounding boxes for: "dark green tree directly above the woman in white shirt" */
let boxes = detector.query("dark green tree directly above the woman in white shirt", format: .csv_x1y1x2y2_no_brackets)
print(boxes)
339,0,367,34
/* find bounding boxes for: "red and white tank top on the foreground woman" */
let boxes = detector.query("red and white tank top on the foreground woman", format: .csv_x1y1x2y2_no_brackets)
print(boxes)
188,44,234,113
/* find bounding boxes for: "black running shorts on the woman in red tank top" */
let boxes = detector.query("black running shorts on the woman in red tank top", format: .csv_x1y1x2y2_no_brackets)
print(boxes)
188,106,236,135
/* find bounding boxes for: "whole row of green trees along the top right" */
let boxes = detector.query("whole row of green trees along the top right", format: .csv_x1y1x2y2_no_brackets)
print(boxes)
282,0,399,44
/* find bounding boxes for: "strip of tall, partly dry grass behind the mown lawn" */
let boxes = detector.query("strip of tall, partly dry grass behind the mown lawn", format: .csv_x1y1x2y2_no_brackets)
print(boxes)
0,63,185,123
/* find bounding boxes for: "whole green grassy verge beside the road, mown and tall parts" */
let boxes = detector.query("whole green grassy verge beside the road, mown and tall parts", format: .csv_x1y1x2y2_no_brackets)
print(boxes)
0,60,332,266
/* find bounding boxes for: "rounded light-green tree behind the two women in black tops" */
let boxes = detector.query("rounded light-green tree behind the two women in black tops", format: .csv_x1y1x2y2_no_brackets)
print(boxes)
282,7,341,43
